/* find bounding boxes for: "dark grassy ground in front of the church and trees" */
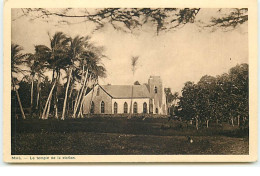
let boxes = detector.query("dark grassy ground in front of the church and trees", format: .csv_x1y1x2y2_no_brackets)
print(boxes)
12,118,249,155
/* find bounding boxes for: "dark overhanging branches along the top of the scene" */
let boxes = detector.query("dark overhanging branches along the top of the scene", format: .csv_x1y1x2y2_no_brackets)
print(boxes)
18,8,248,35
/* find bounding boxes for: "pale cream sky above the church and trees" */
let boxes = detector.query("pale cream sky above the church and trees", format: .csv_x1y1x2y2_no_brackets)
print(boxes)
12,9,248,93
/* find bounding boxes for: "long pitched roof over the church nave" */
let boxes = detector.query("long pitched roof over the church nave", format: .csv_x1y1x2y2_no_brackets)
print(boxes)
100,85,150,98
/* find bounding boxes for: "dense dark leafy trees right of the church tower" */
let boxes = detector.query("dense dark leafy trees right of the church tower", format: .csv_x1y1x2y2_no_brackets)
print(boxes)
175,64,249,129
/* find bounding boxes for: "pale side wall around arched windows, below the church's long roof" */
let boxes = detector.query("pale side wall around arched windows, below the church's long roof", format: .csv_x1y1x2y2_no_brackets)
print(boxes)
112,98,149,114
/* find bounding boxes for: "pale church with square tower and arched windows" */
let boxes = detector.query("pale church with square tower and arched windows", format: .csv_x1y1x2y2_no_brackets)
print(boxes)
83,76,167,115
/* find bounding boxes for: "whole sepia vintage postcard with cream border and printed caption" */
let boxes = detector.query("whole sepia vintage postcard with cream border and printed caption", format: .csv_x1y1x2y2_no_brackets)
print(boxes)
3,0,258,163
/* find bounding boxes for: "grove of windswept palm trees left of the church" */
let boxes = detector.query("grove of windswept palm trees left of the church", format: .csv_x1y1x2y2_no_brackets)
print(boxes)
11,32,106,118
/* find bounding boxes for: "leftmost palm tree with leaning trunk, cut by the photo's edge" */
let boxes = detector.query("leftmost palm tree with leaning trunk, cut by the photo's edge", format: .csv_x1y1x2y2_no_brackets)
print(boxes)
11,43,29,119
